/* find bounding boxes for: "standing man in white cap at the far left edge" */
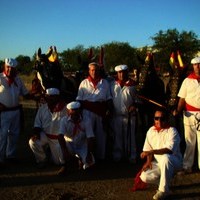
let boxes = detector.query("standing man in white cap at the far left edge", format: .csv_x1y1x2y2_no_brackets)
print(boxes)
0,58,30,167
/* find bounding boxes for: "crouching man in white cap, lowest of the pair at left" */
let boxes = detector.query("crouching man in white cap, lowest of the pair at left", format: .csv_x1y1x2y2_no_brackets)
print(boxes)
58,101,95,175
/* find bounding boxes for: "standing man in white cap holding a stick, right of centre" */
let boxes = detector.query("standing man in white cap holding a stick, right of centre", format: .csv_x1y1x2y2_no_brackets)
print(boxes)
111,65,137,163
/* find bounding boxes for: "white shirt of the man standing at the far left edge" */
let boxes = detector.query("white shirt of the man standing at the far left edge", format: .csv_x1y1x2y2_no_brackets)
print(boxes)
0,73,28,107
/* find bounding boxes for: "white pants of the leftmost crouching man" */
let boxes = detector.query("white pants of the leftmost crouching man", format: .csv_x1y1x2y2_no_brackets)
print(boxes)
29,132,64,165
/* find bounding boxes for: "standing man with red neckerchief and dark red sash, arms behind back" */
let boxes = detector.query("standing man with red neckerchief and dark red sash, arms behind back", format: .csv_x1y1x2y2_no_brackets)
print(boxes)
76,62,112,161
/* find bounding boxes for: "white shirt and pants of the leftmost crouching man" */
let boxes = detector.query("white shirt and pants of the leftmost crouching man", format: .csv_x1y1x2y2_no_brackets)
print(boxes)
29,104,66,165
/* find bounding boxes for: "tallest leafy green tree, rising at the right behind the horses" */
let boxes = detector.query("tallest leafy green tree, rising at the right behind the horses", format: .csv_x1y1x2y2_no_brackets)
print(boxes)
152,29,200,71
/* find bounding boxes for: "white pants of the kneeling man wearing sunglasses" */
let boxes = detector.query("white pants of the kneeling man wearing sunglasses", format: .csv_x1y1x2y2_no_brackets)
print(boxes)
140,154,182,192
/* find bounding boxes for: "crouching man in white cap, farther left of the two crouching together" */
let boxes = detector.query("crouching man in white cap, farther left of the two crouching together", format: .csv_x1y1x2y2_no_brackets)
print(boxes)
29,88,67,168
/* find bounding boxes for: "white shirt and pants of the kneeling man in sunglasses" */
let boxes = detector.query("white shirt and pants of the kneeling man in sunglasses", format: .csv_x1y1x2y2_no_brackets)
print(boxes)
140,126,182,192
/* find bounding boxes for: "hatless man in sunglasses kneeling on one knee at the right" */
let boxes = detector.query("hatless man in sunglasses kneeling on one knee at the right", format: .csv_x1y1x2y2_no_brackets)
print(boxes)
140,109,182,199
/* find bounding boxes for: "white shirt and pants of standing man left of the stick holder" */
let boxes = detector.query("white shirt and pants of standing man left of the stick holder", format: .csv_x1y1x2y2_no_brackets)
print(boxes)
76,78,111,160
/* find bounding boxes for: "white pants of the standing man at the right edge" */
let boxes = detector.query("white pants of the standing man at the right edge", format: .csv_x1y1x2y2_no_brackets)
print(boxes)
183,112,200,169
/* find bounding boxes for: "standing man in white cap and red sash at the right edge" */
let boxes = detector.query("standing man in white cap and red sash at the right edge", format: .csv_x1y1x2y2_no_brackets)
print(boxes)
174,57,200,173
